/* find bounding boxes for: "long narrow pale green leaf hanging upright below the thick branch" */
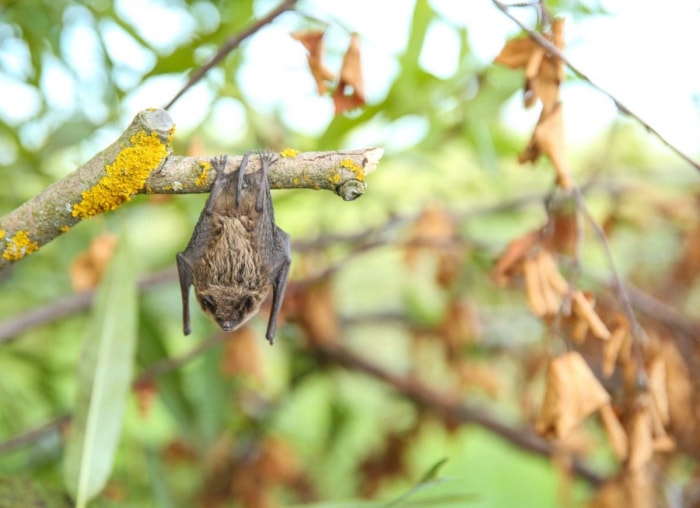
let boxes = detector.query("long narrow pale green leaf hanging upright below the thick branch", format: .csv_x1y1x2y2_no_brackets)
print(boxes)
64,237,137,507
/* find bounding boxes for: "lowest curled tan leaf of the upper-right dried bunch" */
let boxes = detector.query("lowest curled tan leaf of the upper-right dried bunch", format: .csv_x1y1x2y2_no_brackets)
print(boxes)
518,102,573,189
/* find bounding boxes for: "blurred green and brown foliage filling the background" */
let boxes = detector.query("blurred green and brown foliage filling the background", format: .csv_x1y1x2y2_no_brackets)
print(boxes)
0,0,700,508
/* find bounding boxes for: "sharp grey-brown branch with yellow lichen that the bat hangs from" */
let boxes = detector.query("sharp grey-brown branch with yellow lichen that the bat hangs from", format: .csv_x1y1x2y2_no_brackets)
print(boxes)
0,109,383,270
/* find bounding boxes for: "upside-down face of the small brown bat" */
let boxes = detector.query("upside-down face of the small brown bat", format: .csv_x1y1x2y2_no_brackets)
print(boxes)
195,286,269,332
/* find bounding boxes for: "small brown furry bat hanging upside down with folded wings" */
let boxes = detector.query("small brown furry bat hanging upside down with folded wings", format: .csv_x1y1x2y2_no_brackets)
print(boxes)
177,153,291,344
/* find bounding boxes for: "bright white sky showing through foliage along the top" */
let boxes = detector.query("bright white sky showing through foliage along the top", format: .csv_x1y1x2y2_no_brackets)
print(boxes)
0,0,700,162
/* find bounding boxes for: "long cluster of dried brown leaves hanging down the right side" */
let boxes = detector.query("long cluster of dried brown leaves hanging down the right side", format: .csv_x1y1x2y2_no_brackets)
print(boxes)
491,16,700,507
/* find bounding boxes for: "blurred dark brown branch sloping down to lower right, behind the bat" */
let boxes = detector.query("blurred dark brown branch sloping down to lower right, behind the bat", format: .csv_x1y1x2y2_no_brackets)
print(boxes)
317,346,606,486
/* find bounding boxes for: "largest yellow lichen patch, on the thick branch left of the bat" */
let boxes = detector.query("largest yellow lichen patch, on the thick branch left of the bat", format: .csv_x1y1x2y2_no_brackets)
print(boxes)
72,131,168,218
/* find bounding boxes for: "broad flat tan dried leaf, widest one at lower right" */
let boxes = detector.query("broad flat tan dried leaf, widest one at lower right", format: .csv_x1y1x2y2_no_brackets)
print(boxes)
537,351,610,438
